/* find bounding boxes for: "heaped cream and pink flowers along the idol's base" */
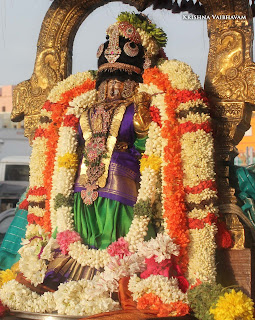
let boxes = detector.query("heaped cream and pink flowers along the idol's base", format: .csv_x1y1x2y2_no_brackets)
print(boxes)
0,232,189,316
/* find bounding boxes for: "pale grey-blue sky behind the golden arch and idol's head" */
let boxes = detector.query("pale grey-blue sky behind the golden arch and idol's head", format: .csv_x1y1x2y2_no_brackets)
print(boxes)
0,0,209,86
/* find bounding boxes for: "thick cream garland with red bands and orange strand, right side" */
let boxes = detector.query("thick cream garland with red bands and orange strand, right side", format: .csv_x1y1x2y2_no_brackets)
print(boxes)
138,60,218,283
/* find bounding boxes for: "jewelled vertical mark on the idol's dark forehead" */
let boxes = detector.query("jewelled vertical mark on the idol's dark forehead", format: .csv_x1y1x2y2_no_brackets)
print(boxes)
104,25,121,63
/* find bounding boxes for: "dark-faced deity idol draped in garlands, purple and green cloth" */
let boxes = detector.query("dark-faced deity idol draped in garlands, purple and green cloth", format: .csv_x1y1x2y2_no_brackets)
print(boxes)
0,12,220,316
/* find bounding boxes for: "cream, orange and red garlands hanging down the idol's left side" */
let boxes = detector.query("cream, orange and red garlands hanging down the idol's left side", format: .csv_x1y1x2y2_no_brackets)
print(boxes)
17,72,95,284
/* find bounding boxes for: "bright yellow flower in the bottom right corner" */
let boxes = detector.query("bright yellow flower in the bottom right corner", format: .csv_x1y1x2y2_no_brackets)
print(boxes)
210,289,254,320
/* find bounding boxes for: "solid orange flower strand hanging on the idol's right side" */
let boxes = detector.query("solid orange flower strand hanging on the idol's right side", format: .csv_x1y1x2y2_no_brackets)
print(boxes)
144,67,189,272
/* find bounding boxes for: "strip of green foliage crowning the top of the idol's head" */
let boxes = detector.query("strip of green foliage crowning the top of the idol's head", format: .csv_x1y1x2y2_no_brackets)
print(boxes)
118,12,167,47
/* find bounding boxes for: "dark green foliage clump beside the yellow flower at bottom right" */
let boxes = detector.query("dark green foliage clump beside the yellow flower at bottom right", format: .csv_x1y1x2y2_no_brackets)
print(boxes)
188,283,224,320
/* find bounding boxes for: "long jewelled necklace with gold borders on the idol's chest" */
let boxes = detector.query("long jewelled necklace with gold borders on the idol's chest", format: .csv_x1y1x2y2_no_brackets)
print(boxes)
79,101,130,205
